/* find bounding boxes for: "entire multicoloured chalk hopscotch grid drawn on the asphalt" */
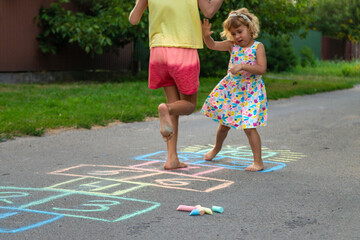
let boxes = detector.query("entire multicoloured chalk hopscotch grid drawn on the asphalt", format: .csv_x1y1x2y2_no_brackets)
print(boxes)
0,145,306,233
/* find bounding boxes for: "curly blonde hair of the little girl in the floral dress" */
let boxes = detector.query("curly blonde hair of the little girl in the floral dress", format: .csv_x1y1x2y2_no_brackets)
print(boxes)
220,8,260,40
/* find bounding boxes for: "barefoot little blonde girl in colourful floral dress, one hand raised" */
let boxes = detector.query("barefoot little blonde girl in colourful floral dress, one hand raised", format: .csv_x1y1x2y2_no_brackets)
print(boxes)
201,8,267,172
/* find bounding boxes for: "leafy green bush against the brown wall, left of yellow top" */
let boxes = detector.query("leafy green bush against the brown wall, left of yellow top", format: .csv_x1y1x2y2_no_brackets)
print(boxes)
35,0,147,55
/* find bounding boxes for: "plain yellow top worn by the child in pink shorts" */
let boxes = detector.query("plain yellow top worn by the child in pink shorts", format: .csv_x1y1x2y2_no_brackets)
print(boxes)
148,0,203,48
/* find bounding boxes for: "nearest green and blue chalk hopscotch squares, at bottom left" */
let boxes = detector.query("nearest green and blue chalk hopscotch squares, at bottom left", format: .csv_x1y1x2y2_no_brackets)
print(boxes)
0,186,160,233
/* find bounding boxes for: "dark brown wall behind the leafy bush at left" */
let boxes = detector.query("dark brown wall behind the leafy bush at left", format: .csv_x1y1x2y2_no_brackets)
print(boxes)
0,0,133,72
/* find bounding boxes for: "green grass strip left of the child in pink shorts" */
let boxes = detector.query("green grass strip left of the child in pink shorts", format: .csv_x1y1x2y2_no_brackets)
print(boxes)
0,81,164,137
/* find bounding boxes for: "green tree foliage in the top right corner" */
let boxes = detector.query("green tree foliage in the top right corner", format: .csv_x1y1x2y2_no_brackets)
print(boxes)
313,0,360,42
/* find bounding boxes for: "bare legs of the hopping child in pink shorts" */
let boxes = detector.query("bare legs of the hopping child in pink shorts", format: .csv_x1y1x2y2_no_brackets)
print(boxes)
159,86,197,169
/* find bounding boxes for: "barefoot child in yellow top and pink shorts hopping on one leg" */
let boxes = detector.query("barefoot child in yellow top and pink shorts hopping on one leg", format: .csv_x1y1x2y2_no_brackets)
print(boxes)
129,0,223,169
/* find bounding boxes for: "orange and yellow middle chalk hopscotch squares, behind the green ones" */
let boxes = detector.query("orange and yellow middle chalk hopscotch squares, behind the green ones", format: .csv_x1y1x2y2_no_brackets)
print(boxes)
49,164,234,195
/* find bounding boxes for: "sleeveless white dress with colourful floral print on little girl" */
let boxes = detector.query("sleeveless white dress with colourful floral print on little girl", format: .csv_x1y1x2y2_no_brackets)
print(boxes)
201,41,267,129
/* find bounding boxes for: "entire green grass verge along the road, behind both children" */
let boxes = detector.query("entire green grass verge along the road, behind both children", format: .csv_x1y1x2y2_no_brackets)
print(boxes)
0,62,360,138
